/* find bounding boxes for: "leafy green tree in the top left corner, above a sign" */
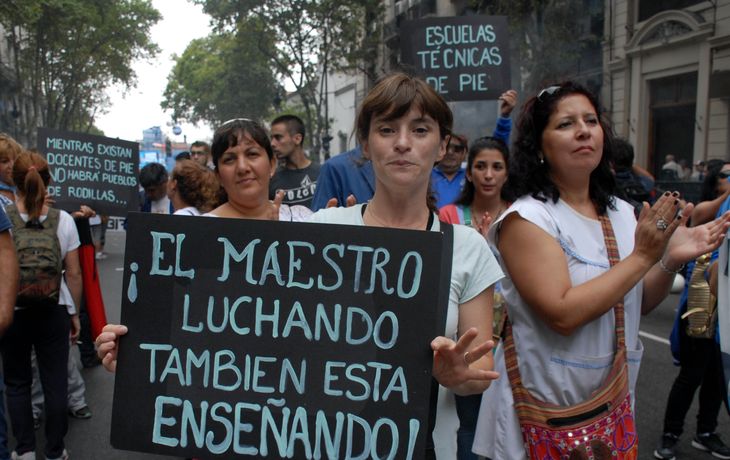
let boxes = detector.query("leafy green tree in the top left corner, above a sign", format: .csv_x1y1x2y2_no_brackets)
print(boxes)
0,0,160,142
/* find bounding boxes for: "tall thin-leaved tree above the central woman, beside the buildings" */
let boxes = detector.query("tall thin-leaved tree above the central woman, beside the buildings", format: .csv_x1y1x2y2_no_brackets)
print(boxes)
195,0,382,155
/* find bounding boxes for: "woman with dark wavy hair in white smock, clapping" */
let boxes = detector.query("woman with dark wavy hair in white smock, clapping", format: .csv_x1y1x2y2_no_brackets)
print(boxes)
474,82,730,460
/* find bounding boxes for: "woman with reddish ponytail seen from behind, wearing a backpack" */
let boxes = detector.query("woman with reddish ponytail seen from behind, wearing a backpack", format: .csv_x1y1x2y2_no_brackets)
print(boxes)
2,152,82,460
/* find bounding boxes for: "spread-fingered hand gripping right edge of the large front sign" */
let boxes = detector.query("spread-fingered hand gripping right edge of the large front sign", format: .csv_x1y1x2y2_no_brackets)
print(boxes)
431,327,499,388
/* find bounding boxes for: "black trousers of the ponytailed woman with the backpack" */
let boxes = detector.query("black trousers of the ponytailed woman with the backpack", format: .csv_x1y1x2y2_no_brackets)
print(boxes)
1,306,70,458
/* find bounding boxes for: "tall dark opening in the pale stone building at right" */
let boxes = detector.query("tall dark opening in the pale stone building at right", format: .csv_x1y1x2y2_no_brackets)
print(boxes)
649,72,697,180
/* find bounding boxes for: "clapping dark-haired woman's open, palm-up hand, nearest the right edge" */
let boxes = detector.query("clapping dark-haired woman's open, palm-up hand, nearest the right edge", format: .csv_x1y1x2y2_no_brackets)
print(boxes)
662,209,730,269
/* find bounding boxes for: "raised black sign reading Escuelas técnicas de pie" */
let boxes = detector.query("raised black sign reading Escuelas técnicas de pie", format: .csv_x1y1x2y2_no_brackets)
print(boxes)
401,16,511,101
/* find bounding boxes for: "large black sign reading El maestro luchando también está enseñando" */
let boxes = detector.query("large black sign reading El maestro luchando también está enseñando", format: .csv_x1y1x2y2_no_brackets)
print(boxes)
111,213,450,459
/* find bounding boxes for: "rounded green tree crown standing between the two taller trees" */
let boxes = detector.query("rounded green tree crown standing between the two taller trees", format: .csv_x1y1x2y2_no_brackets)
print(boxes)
161,21,276,125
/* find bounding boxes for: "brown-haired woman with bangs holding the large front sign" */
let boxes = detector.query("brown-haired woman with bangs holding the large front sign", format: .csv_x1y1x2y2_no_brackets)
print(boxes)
311,74,502,459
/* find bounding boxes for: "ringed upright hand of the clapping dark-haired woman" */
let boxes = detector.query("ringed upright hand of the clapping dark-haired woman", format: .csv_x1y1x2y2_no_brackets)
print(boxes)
634,192,691,266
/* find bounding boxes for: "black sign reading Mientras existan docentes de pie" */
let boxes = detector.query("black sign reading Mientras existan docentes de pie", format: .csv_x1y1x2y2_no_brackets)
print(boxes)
38,128,139,216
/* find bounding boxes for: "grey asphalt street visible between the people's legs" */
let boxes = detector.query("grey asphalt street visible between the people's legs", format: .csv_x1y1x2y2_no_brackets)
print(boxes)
18,232,730,460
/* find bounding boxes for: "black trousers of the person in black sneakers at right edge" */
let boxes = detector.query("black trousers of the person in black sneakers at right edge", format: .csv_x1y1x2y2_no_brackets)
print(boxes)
664,328,725,436
